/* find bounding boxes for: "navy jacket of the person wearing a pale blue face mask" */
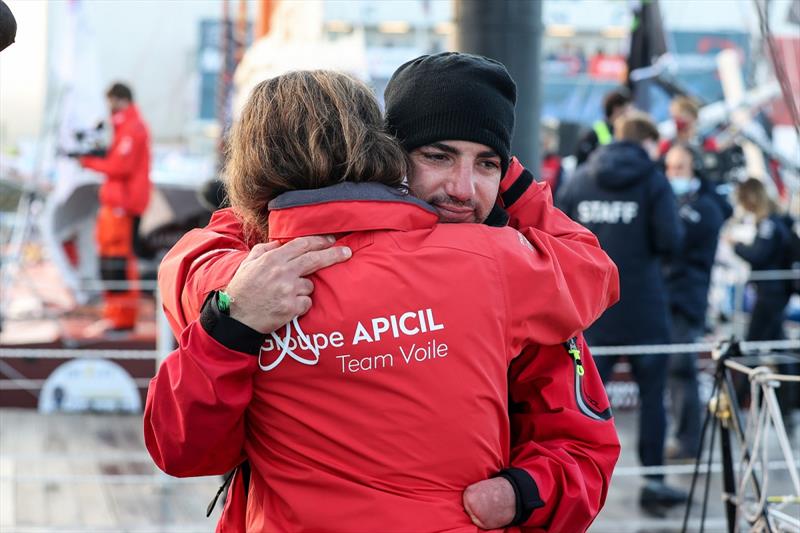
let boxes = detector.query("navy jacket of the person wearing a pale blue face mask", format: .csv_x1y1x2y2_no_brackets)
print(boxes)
664,181,733,326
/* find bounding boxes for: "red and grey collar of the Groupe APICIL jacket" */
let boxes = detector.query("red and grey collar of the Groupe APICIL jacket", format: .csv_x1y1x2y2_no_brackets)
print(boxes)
269,182,439,240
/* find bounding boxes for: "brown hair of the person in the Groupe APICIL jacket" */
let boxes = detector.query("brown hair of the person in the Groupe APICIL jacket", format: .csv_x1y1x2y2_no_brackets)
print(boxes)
225,70,408,238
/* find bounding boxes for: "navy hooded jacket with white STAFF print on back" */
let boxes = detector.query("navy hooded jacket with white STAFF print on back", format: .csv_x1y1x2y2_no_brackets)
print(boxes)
558,142,683,345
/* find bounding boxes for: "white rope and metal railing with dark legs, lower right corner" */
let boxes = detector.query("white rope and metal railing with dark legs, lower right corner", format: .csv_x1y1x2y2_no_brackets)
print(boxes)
681,341,800,532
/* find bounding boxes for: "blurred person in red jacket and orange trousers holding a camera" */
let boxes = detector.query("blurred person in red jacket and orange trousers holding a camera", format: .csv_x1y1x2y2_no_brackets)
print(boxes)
79,83,150,335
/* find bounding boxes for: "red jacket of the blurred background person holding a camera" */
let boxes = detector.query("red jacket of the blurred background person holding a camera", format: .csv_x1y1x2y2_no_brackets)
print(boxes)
80,104,150,216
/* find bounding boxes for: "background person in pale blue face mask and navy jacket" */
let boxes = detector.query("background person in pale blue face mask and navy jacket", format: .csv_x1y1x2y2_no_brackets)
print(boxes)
664,143,732,459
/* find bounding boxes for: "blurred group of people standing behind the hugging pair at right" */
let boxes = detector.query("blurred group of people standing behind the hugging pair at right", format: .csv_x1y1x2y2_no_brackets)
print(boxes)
541,88,798,514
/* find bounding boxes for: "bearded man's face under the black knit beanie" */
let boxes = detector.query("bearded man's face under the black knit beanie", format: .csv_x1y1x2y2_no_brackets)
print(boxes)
408,141,501,223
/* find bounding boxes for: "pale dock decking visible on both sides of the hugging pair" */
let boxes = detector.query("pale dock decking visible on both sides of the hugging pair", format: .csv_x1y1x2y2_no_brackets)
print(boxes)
0,409,800,533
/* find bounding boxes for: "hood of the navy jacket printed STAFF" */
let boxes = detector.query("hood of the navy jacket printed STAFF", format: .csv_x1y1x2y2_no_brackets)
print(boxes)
587,141,655,189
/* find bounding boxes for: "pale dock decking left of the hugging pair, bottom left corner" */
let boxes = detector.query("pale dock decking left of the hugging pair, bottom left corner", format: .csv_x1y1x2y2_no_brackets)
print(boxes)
0,409,220,533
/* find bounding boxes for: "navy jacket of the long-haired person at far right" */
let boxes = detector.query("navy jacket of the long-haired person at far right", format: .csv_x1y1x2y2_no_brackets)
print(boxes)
736,214,790,297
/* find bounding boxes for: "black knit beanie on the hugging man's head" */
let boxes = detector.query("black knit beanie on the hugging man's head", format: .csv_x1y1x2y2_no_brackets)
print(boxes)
384,52,517,175
